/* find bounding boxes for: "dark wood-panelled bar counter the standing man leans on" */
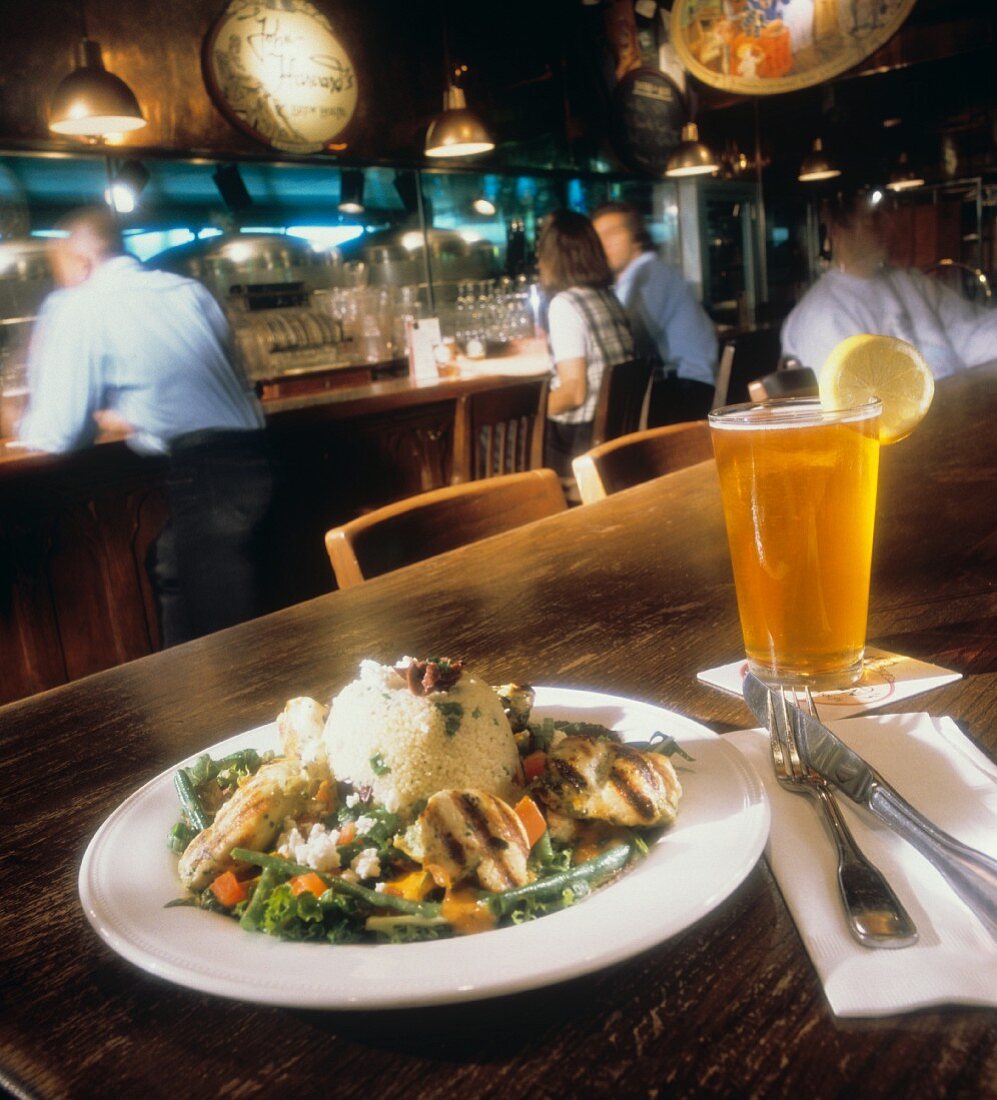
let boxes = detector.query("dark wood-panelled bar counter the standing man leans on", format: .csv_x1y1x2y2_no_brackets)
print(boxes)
0,359,537,703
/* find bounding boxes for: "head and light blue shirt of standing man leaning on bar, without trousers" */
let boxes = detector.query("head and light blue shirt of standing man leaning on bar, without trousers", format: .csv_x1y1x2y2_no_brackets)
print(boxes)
19,211,263,453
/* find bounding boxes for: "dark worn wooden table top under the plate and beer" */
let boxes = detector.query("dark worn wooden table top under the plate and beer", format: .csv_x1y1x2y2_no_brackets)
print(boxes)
0,365,997,1098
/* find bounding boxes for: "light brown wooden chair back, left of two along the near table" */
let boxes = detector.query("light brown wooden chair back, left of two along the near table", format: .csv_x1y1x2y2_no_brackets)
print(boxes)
326,470,567,589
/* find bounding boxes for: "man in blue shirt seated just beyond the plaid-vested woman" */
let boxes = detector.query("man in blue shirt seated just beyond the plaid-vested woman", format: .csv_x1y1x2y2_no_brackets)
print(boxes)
592,202,716,426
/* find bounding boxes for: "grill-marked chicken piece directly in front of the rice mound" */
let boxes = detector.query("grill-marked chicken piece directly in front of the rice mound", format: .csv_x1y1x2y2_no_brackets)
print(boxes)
418,790,529,891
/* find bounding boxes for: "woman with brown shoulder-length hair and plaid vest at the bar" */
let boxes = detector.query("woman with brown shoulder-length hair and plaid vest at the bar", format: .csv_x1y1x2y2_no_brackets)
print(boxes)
537,210,634,479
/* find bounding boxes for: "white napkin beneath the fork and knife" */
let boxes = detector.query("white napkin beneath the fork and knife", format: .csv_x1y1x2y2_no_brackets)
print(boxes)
726,714,997,1016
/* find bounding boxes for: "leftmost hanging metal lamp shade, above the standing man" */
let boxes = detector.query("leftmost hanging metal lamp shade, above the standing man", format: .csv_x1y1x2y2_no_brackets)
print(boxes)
48,39,145,138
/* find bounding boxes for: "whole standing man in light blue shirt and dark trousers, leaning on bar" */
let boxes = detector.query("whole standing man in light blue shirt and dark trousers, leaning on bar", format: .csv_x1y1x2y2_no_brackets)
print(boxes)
19,207,273,646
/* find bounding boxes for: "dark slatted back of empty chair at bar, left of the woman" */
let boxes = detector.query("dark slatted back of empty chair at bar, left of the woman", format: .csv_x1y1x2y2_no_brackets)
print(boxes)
451,376,548,484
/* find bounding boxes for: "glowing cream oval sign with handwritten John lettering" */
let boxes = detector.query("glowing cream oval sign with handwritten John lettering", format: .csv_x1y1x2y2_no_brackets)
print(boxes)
204,0,357,153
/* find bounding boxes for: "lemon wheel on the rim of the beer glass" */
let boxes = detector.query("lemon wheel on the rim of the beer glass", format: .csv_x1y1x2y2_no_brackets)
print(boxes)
819,333,934,443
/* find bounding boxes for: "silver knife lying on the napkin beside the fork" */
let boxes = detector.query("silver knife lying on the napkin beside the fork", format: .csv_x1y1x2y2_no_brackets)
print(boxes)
744,672,997,939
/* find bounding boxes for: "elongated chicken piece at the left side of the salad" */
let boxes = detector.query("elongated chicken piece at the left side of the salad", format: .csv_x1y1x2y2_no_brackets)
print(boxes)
177,759,316,890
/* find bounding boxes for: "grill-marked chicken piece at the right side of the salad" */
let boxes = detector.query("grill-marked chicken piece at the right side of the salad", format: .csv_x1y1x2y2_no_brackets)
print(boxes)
537,734,682,826
